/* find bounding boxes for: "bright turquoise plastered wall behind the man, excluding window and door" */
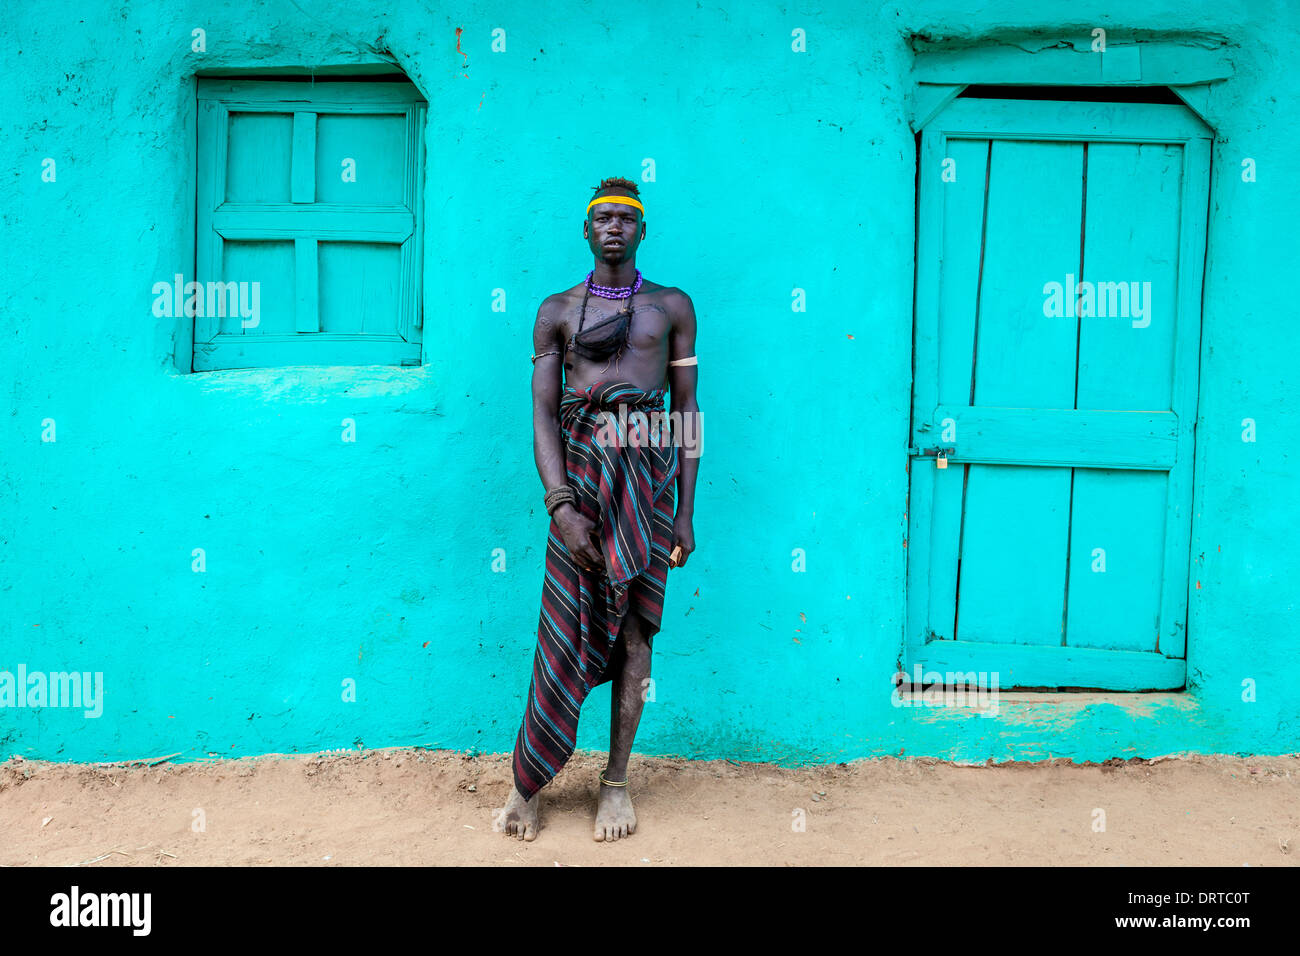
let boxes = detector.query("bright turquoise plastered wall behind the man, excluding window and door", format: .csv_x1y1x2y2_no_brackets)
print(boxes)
0,0,1300,762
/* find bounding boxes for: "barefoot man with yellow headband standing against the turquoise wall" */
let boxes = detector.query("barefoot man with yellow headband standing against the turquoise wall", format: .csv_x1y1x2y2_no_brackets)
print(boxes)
497,178,699,840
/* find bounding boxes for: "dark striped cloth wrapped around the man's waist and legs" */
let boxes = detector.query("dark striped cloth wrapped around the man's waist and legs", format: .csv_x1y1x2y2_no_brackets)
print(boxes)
514,381,677,799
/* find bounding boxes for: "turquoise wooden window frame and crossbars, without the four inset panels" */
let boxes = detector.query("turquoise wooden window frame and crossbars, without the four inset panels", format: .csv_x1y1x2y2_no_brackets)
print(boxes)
192,78,428,372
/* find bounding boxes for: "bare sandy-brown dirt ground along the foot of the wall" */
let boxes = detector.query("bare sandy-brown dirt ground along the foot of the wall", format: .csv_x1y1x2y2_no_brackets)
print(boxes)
0,749,1300,866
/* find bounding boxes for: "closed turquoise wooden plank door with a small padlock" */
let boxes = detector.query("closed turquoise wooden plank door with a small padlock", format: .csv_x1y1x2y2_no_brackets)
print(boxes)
904,99,1210,691
